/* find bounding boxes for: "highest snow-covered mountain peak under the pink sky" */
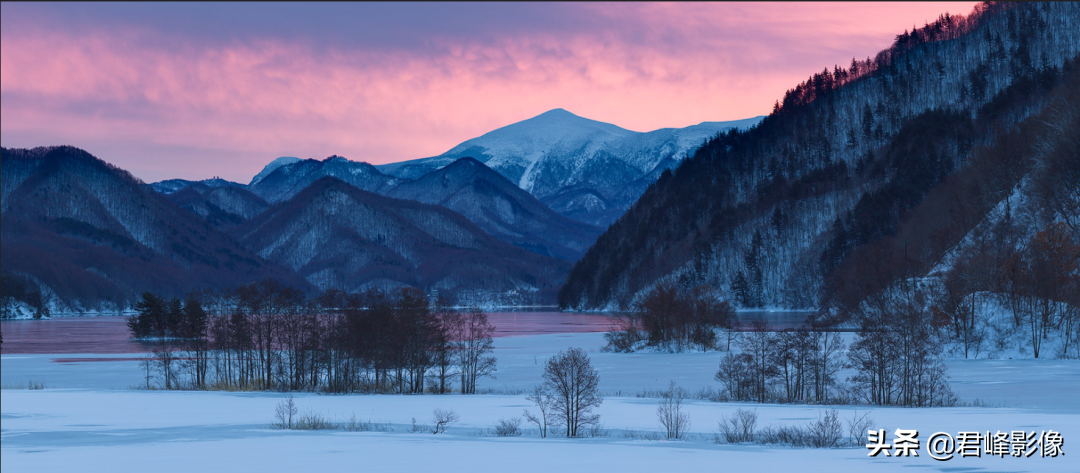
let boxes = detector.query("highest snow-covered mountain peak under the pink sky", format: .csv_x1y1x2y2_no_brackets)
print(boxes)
377,109,761,227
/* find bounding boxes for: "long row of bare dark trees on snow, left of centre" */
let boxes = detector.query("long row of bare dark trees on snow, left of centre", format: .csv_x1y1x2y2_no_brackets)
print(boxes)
130,280,496,393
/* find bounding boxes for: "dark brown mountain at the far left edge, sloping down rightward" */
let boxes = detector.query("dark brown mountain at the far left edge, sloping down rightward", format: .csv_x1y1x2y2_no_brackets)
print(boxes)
0,147,308,311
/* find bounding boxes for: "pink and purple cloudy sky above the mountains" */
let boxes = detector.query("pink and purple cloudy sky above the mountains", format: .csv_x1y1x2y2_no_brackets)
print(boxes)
0,2,975,183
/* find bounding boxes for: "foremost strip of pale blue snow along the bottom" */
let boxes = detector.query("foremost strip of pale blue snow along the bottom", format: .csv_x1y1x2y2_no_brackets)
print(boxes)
0,390,1080,472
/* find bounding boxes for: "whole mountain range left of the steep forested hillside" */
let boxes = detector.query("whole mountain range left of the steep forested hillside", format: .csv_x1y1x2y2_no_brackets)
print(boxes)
2,109,758,311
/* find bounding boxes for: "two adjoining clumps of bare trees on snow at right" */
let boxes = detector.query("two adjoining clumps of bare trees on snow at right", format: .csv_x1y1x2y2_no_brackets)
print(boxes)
715,300,956,407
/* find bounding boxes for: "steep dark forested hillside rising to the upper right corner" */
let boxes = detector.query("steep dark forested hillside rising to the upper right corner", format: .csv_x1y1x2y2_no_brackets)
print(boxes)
559,2,1080,309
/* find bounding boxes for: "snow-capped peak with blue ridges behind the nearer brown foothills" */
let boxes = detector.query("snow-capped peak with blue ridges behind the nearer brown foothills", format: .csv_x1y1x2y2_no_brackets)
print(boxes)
141,109,760,261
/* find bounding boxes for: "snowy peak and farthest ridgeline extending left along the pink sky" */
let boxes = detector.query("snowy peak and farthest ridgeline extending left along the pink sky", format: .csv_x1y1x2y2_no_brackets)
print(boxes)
152,109,762,228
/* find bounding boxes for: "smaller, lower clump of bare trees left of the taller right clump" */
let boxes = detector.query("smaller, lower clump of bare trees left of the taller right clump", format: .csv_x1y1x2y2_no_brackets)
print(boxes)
715,321,845,403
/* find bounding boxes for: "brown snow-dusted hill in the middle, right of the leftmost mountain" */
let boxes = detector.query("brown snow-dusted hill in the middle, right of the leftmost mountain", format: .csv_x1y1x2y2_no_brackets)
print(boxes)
234,177,569,299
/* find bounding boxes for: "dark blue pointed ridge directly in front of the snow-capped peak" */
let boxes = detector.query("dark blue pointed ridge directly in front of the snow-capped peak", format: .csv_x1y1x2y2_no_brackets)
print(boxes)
388,158,600,261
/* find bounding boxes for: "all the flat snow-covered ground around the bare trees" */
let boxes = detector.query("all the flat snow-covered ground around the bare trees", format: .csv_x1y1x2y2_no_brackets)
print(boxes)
0,334,1080,472
